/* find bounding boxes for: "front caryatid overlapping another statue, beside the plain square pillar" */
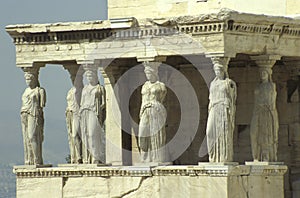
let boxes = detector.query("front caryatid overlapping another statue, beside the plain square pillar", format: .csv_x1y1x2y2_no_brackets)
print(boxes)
80,68,105,164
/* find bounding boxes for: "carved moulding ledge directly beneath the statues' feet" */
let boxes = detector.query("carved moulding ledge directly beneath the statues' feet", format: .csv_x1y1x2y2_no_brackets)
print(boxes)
14,164,287,178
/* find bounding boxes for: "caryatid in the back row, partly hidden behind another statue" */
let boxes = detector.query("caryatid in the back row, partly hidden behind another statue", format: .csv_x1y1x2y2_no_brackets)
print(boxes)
66,70,83,164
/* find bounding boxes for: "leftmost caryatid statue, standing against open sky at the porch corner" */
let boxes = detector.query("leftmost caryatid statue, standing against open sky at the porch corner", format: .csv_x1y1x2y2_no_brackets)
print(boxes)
21,68,46,165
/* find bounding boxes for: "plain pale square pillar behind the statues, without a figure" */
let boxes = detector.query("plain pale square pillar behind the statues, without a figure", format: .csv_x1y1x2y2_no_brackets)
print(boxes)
100,67,123,165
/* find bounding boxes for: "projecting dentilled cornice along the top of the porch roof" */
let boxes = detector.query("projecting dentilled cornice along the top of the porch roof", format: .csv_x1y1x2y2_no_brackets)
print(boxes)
6,9,300,45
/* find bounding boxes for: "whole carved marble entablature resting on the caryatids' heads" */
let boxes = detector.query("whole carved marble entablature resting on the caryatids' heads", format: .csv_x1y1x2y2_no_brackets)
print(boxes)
6,9,300,65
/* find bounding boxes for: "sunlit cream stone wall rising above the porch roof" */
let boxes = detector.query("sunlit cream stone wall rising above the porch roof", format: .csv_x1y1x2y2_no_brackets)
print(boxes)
108,0,288,19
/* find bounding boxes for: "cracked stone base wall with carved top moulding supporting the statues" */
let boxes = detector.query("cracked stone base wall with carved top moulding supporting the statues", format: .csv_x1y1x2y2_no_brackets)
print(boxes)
14,164,287,198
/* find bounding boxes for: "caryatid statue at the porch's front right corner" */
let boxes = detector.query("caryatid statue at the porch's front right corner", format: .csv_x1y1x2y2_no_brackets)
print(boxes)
206,58,237,162
